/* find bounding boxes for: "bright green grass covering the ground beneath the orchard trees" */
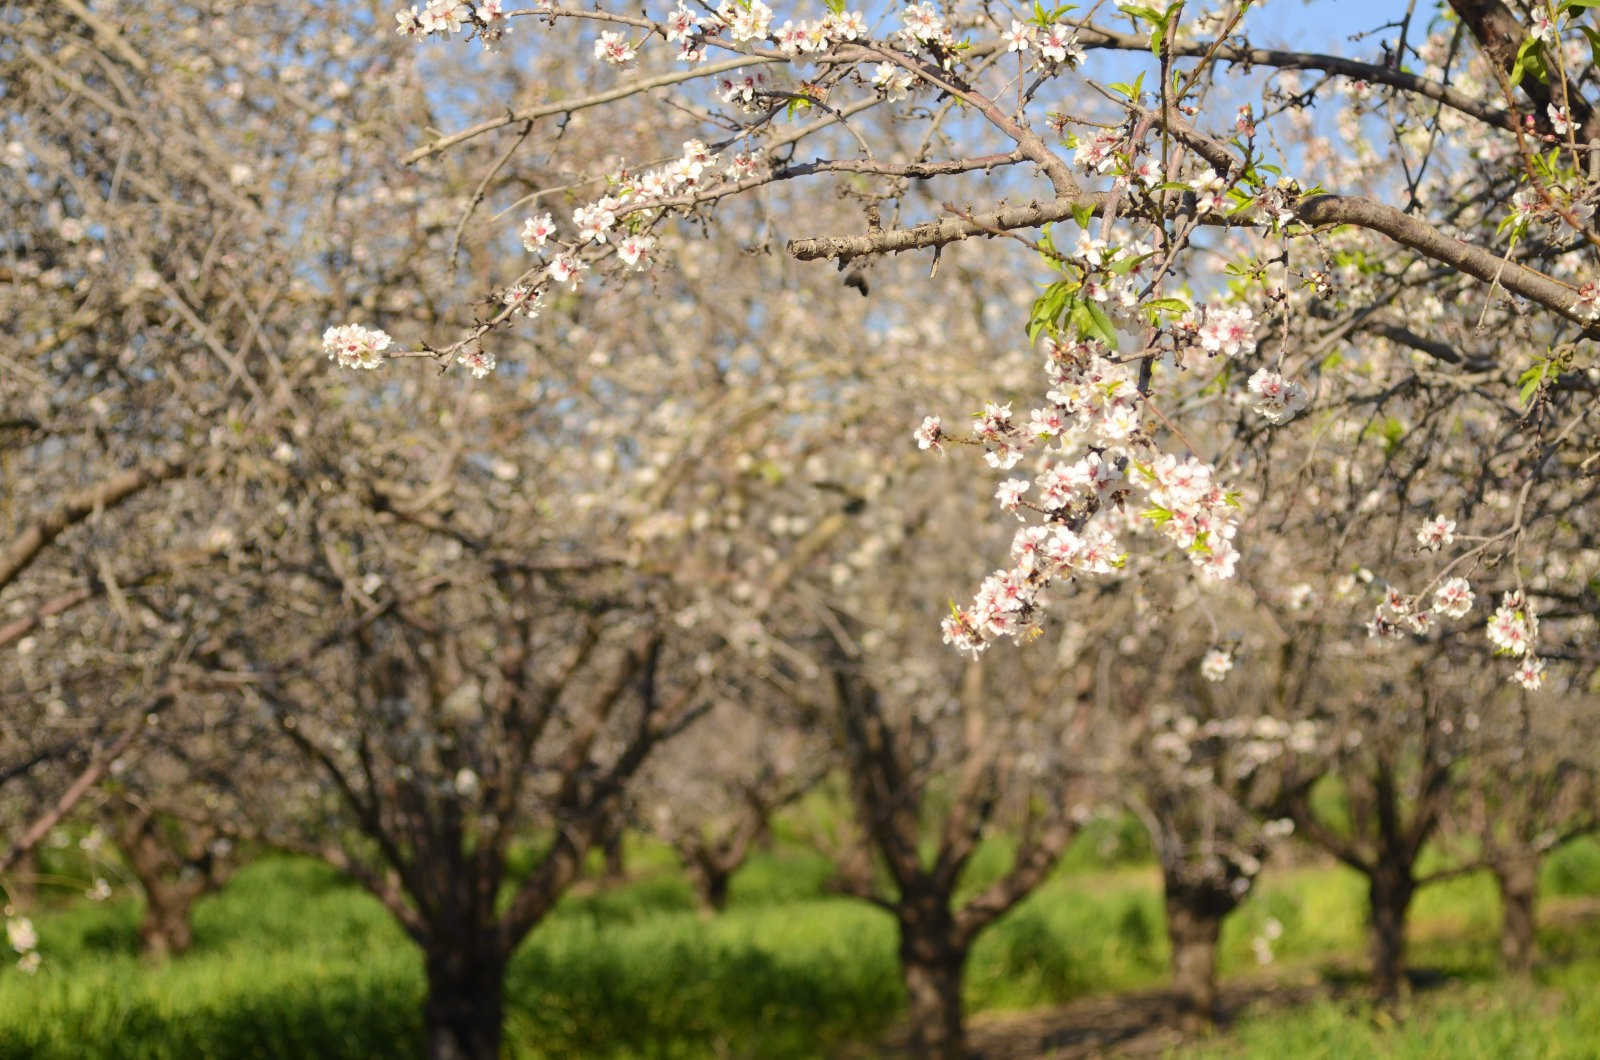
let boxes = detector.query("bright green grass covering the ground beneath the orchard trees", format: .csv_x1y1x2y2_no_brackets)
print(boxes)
0,844,1600,1060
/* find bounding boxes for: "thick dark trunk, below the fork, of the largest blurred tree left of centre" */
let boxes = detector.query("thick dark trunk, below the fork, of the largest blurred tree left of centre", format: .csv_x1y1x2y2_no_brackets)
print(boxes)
422,938,506,1060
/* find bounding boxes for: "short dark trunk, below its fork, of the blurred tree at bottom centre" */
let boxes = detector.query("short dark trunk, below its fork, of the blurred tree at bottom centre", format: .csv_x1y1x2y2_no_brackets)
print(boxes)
899,893,966,1060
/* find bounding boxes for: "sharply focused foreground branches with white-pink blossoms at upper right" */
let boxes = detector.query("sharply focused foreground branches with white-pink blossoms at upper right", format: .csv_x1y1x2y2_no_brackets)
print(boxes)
344,0,1600,685
